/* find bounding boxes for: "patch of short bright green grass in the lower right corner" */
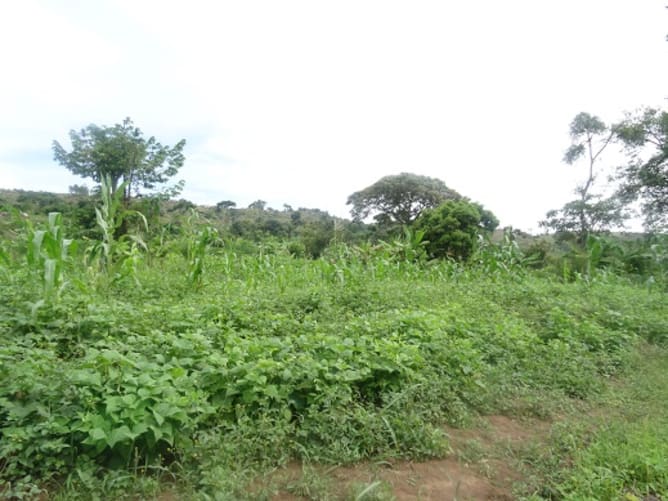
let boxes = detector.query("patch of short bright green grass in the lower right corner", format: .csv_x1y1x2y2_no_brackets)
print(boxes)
519,346,668,501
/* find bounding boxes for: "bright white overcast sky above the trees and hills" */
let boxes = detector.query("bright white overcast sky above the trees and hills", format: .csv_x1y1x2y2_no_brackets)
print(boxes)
0,0,668,232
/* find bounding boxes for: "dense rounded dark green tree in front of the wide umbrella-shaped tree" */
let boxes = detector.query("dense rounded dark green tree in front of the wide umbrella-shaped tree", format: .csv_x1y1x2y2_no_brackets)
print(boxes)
414,200,499,261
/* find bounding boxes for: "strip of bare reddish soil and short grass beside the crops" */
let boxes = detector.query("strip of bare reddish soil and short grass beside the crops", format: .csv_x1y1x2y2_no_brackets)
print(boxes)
265,345,668,501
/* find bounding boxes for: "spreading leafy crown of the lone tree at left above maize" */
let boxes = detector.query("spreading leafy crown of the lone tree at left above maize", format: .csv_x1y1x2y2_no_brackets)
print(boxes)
53,118,186,201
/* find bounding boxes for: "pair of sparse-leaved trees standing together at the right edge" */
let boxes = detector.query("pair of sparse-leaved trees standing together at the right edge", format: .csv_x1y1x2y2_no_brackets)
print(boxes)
541,108,668,235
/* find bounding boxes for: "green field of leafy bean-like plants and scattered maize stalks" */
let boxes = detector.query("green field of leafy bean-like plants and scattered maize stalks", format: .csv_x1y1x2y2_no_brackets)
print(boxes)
0,210,668,499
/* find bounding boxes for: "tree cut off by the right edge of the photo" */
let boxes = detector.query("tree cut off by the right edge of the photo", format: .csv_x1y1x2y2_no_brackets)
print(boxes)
617,108,668,230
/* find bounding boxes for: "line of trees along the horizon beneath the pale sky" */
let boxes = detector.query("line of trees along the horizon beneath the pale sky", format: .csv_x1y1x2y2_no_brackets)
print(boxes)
30,103,668,260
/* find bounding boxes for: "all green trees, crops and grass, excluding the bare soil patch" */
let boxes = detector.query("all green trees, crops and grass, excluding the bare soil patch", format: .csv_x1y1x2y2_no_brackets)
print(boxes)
0,104,668,500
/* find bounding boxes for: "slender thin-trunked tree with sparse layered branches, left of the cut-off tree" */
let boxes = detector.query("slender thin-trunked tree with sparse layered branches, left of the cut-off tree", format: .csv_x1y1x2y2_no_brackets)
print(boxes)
540,112,626,243
